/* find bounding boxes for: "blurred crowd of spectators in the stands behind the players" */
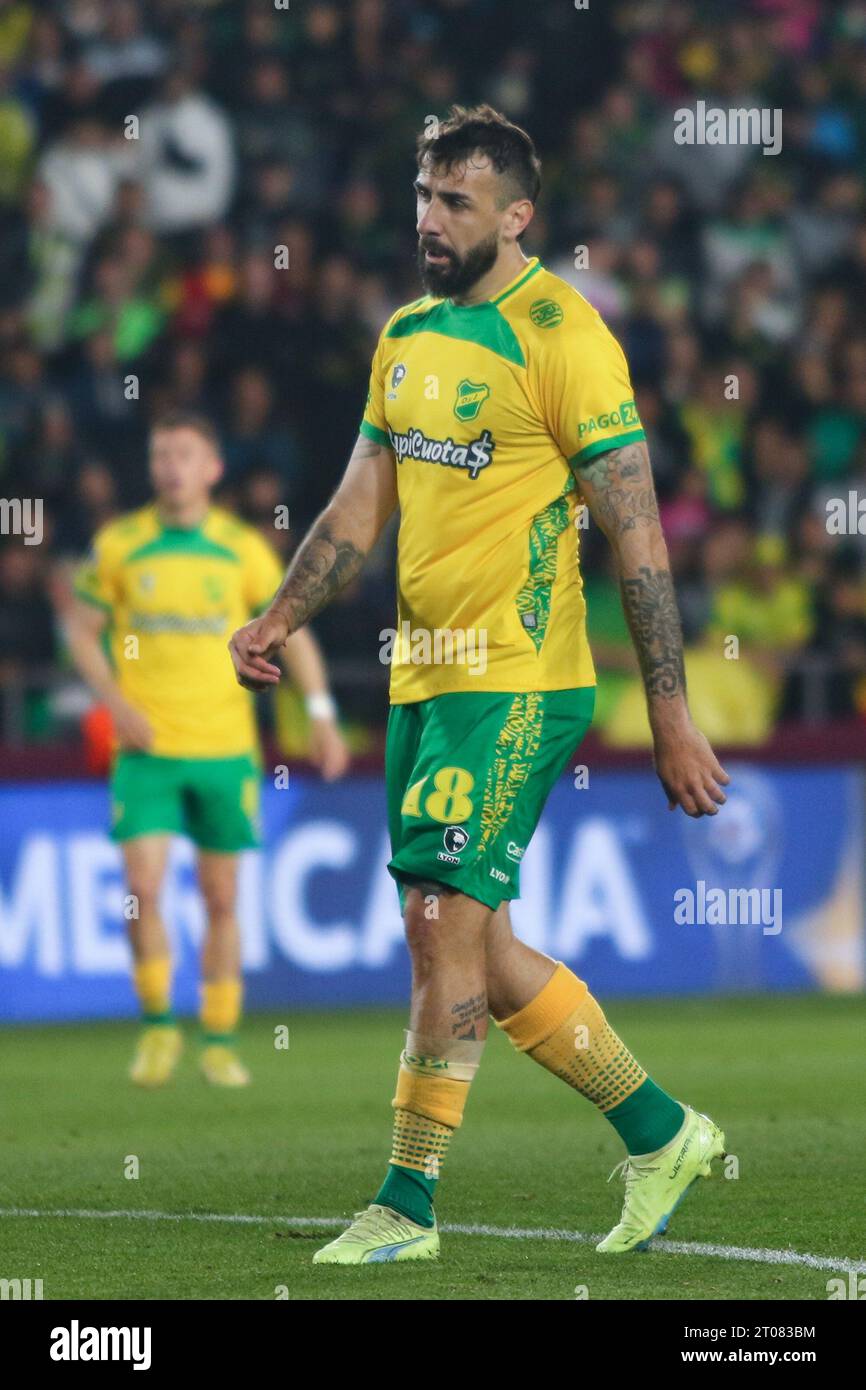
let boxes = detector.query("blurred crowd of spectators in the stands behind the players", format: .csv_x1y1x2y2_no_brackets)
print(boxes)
0,0,866,744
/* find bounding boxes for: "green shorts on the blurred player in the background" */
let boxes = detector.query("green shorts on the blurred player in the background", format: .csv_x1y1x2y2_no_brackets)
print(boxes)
111,752,261,853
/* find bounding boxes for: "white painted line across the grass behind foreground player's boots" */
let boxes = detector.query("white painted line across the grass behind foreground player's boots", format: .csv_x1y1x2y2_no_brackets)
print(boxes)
0,1207,866,1275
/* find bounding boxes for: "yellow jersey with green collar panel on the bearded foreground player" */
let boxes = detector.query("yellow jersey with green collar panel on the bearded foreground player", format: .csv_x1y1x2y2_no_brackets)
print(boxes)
360,257,645,705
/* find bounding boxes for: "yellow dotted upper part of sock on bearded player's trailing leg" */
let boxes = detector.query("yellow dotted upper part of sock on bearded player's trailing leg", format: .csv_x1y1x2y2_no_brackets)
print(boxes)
499,962,646,1112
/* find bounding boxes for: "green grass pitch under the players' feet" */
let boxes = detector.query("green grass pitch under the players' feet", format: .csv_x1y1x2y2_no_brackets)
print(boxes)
0,997,866,1300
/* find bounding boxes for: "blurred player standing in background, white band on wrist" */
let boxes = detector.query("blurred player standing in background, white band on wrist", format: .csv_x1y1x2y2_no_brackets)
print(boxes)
70,413,348,1087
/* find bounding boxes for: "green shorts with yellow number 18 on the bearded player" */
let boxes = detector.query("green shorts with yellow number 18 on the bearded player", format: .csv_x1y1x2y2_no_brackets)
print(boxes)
385,685,595,909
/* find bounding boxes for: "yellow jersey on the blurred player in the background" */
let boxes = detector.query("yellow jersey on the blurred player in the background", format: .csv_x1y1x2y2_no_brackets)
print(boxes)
75,505,282,758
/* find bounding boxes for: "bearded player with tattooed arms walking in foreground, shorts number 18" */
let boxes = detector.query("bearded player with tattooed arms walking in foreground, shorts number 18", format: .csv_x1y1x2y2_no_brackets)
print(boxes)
231,106,728,1265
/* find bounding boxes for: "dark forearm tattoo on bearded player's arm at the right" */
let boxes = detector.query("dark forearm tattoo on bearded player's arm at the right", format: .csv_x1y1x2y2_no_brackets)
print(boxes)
620,564,685,699
